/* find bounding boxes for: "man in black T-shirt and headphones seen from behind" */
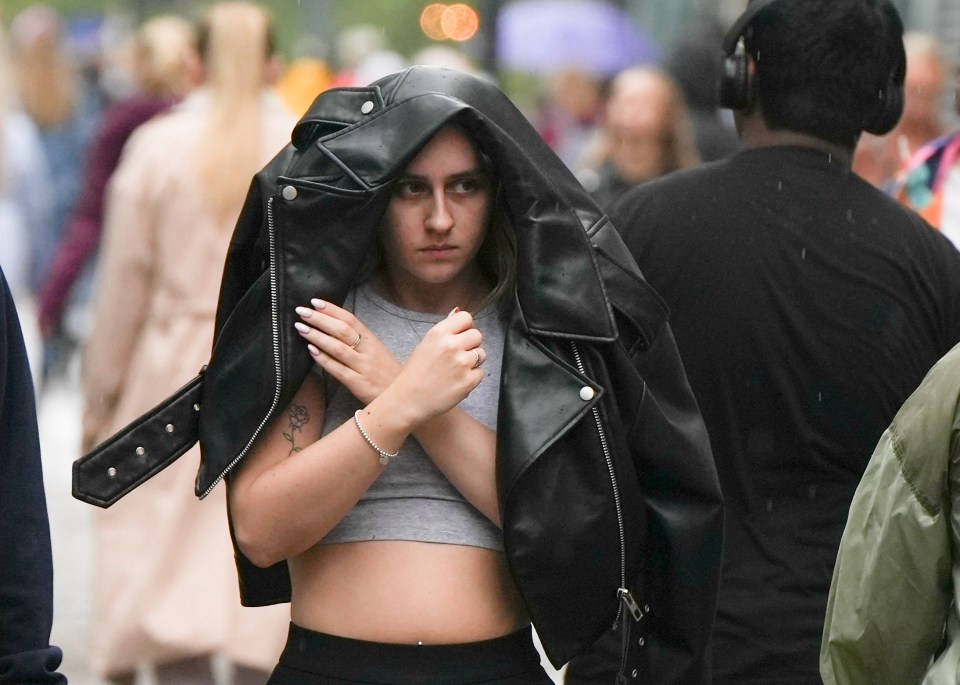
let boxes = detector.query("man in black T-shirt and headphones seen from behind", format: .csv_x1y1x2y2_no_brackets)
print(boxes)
567,0,960,685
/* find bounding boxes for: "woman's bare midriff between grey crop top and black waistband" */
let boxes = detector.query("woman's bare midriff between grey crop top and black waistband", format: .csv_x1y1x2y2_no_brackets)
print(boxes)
290,540,529,644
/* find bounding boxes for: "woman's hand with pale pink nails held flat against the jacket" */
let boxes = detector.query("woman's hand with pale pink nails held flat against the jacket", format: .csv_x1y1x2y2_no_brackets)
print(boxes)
294,299,403,404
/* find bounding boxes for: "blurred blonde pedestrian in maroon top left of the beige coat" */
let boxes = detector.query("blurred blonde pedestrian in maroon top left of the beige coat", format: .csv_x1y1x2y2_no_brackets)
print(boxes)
37,15,197,350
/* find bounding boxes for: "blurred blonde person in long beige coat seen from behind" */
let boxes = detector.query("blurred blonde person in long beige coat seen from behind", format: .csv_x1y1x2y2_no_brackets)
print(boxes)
82,2,295,685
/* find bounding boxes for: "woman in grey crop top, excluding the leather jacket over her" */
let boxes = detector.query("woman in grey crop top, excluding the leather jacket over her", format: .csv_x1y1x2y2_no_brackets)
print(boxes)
230,121,551,683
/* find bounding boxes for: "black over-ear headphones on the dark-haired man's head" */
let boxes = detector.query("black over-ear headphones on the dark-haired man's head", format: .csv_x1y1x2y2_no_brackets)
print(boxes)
720,0,907,135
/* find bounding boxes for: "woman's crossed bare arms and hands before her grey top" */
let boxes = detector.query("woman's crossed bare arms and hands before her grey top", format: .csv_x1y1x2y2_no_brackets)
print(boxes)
229,300,500,566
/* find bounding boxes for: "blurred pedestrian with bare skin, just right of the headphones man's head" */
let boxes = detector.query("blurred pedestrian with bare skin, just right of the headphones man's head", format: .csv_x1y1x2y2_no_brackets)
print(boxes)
853,31,948,188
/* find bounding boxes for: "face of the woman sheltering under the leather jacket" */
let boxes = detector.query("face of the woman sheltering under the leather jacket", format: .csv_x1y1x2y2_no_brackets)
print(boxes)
383,127,493,298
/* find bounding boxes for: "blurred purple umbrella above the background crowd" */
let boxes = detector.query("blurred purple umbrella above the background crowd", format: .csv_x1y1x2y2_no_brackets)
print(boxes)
497,0,659,76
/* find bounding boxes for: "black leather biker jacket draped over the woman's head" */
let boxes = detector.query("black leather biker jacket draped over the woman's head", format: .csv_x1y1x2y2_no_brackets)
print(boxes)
75,67,722,685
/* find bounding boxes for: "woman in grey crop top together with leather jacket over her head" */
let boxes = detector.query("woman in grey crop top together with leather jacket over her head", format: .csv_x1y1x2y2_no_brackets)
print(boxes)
74,66,721,685
